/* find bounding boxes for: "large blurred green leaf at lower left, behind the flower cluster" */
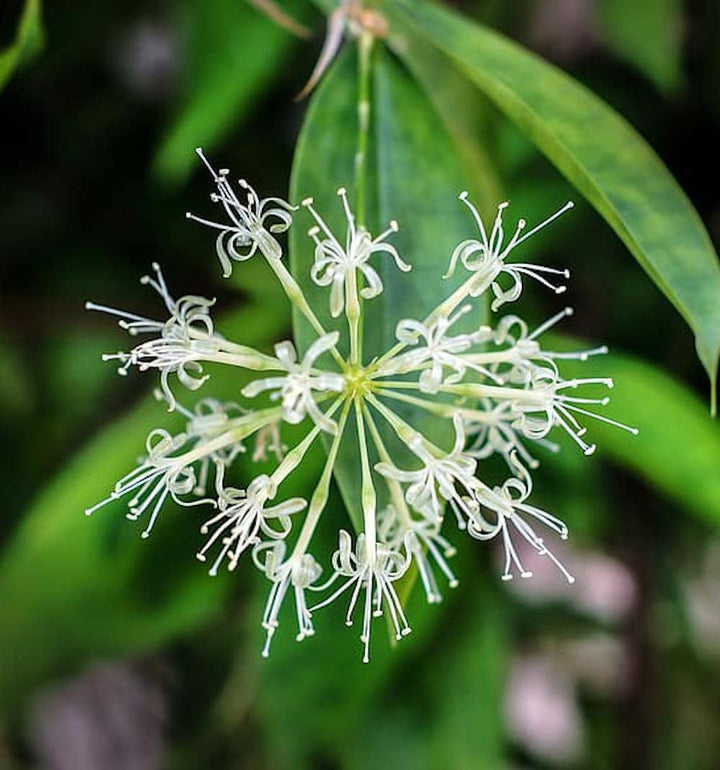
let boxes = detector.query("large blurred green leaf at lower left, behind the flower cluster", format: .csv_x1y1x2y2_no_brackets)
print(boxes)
0,262,286,711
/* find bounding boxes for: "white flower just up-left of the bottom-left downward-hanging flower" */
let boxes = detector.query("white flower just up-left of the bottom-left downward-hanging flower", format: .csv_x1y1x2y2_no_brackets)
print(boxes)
197,466,307,575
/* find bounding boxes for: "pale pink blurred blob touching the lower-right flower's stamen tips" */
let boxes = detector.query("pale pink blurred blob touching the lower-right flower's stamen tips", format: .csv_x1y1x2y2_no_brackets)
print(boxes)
498,542,637,623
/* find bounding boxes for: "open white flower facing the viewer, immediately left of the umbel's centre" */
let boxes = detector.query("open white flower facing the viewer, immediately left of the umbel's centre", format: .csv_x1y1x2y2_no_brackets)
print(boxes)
242,332,345,433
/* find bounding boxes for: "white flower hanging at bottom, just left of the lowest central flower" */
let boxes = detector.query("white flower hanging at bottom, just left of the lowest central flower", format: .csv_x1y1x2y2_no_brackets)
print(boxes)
253,540,322,658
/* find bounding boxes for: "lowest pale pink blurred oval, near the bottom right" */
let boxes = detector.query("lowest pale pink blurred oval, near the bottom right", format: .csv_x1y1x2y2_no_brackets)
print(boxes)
505,655,584,764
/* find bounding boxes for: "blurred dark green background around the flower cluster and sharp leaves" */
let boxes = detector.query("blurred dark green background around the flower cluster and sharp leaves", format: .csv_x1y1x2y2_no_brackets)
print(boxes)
0,0,720,770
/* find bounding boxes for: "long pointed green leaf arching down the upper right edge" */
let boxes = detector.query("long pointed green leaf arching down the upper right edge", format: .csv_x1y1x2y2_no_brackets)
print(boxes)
384,0,720,403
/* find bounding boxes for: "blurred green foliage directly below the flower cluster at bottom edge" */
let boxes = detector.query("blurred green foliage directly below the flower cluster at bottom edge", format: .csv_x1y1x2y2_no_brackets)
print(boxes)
256,544,508,770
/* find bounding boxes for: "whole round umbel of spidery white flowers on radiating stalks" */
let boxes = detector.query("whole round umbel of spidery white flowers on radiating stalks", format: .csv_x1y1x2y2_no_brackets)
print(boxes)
86,150,634,661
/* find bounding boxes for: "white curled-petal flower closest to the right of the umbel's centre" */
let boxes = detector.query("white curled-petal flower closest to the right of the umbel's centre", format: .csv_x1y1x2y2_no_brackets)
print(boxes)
376,305,496,394
